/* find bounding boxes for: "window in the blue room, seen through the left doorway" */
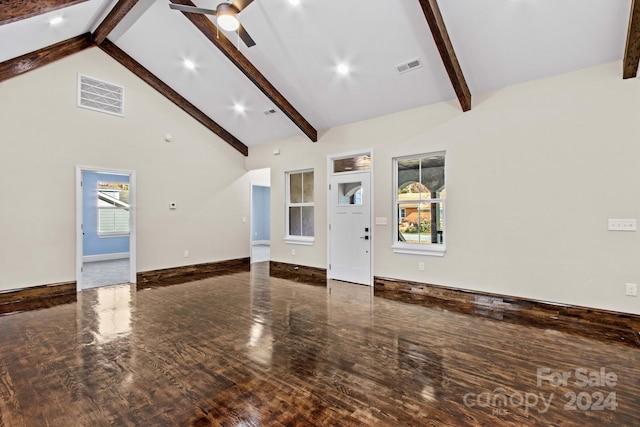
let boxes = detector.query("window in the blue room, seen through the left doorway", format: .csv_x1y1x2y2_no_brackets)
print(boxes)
98,182,129,236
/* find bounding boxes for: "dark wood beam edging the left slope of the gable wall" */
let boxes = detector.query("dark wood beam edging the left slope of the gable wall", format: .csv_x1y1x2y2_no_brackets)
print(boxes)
0,33,92,82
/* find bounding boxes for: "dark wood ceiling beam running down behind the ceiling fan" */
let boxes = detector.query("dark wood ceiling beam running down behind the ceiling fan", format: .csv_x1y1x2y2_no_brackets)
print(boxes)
171,0,318,142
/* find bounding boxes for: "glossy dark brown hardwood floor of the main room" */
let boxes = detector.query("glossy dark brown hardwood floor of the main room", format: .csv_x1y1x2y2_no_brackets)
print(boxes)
0,263,640,427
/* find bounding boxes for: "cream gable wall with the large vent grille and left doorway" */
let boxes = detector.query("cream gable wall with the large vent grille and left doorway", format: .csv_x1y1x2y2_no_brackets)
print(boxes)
0,48,250,290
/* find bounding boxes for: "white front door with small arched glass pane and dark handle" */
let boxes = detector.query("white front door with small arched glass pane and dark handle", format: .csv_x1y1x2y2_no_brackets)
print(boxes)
328,171,372,285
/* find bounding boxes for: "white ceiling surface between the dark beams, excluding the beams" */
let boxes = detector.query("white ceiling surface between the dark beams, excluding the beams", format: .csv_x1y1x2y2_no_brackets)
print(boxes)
0,0,631,146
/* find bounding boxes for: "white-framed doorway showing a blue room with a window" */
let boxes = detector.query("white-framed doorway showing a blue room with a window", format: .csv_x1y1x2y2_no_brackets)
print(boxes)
76,166,136,291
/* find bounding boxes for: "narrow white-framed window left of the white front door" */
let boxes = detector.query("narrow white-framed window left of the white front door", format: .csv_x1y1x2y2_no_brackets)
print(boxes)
285,170,314,245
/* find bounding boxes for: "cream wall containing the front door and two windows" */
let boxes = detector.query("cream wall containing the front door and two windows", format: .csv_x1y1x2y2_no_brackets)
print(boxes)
247,63,640,314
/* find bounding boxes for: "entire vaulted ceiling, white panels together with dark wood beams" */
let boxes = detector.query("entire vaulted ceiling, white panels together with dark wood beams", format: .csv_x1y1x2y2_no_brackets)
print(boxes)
0,0,640,155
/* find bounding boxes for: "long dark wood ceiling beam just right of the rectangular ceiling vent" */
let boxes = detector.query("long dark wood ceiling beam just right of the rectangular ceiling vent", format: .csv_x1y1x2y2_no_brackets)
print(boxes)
419,0,471,111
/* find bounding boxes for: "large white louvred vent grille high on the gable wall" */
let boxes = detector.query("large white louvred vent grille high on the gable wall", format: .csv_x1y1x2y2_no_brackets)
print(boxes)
78,74,124,116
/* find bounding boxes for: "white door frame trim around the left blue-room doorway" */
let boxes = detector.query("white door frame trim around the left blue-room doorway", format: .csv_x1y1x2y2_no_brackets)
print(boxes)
76,165,137,292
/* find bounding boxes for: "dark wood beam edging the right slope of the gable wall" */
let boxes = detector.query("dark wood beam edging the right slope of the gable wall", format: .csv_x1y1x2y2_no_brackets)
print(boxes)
99,39,249,156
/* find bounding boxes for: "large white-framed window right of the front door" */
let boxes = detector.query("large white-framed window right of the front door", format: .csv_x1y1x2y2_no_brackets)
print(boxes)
393,153,446,256
